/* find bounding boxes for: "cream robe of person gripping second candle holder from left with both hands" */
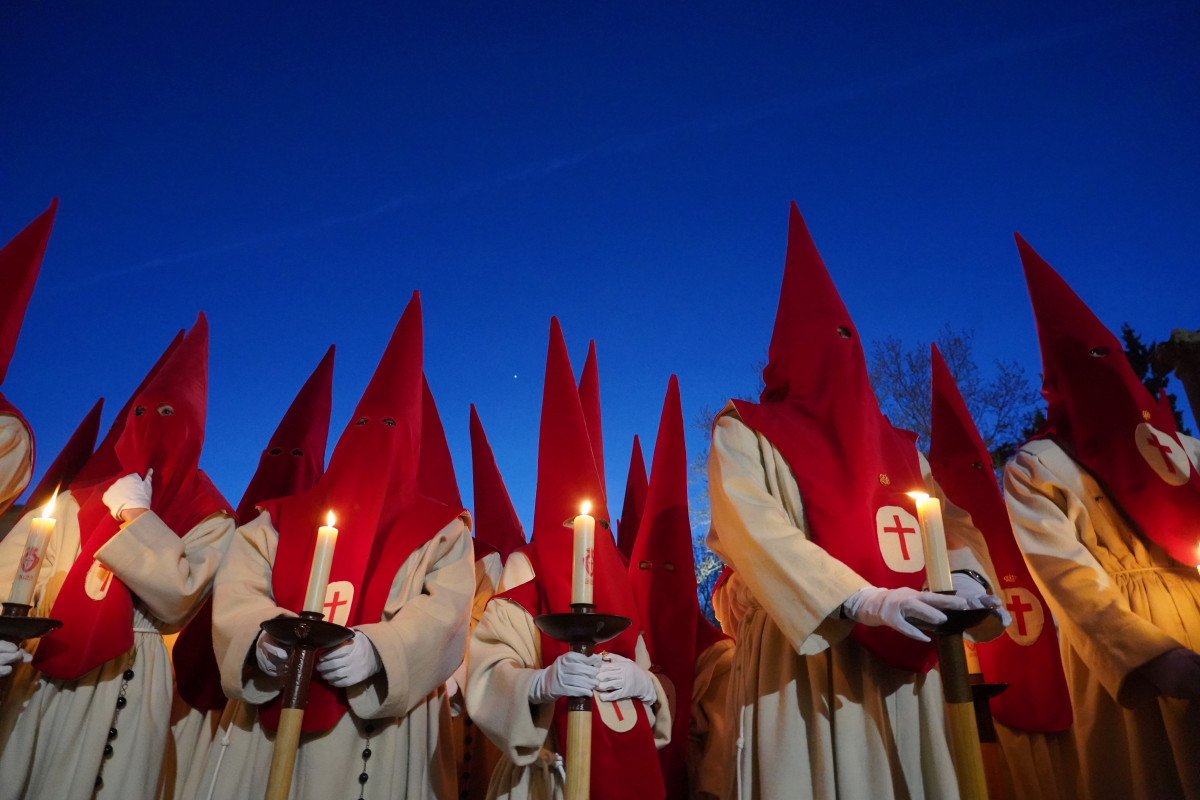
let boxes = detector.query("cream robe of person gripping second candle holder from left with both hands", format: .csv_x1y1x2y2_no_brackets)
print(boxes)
192,512,474,800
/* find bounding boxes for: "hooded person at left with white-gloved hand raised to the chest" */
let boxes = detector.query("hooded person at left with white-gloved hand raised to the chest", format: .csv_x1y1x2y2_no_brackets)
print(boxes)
0,314,234,800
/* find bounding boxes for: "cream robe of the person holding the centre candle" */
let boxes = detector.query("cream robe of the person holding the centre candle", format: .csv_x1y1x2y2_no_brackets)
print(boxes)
467,552,671,800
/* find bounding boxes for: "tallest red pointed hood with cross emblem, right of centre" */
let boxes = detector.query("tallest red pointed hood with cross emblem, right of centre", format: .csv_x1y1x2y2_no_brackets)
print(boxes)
733,203,936,670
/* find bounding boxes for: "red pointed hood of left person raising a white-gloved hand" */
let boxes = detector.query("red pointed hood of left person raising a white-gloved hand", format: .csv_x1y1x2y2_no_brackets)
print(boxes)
34,314,232,680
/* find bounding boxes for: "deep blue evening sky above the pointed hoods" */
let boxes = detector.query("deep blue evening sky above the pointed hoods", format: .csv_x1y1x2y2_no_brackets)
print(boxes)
0,0,1200,529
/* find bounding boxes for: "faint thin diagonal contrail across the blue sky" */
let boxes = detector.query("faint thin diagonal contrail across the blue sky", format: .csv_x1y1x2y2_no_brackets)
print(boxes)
60,2,1188,287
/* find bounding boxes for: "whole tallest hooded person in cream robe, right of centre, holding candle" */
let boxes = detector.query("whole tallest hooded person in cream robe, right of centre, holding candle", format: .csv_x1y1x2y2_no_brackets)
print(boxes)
708,204,1003,800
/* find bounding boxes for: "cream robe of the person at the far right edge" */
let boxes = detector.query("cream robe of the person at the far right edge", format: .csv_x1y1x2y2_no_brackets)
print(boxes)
1004,437,1200,800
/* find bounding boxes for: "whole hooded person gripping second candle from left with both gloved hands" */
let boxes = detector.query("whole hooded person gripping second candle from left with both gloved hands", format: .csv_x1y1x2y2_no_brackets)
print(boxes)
198,294,473,800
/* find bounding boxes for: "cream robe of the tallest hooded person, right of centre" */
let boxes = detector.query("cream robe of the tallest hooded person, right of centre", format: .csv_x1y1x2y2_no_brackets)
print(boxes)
708,407,1002,800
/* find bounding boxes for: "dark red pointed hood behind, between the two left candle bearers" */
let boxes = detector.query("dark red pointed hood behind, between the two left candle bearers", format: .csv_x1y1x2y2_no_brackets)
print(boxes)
236,344,335,524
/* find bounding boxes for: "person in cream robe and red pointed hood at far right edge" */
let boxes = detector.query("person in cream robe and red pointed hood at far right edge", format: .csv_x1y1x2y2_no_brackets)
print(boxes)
1004,236,1200,800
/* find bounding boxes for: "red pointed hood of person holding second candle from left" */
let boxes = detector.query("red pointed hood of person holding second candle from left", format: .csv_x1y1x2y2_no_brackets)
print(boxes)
259,293,462,732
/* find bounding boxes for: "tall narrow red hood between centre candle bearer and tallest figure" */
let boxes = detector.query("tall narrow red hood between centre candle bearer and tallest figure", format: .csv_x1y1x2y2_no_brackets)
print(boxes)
629,375,725,800
